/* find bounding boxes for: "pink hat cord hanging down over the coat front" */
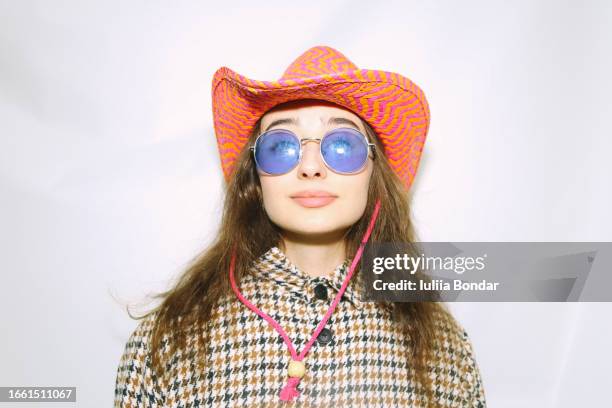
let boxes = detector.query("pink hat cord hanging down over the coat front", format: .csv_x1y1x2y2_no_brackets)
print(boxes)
229,199,380,401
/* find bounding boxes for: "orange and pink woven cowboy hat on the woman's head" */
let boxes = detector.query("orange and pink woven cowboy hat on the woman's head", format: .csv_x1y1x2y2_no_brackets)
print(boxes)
212,45,430,189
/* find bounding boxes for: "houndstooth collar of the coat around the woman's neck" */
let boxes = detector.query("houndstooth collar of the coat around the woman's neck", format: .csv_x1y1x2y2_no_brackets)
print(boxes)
252,246,364,308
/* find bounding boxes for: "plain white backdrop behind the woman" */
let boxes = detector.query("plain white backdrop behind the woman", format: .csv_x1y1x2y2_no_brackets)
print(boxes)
0,0,612,408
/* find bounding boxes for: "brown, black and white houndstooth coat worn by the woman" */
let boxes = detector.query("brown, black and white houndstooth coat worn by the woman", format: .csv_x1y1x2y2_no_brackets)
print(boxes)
114,247,486,408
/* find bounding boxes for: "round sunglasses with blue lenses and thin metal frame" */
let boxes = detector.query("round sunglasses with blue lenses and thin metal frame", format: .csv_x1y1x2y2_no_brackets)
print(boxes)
249,127,376,175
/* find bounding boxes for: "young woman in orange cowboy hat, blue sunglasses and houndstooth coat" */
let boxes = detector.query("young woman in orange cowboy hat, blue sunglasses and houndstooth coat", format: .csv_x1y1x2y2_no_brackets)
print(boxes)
115,46,486,407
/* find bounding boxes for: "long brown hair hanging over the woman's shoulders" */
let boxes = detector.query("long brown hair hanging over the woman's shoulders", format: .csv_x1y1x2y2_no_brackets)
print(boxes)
127,107,462,406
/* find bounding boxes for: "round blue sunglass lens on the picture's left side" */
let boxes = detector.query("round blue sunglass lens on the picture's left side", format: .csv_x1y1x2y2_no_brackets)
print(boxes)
255,129,300,174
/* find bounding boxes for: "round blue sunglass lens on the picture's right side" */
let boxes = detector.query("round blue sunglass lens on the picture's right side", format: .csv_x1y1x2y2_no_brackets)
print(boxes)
321,128,368,173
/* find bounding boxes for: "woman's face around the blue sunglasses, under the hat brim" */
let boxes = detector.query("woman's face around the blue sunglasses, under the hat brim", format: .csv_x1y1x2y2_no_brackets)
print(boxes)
258,100,373,238
